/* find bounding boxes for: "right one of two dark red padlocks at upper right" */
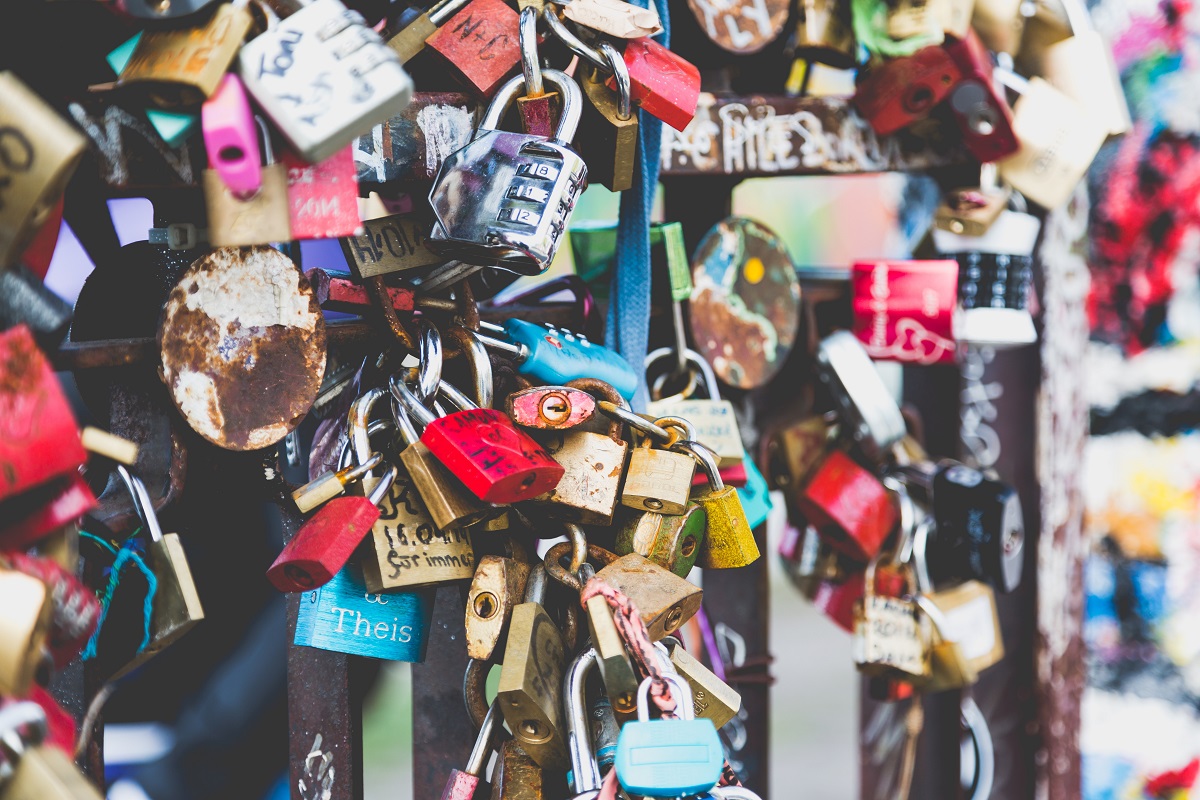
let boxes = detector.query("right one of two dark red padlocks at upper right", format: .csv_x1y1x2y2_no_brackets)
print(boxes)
944,30,1020,163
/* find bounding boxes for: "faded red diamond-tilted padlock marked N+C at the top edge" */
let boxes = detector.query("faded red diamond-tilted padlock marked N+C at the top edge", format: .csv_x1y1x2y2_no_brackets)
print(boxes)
425,0,521,97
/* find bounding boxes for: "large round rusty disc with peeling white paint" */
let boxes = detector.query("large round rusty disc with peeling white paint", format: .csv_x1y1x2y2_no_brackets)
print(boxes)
158,246,325,450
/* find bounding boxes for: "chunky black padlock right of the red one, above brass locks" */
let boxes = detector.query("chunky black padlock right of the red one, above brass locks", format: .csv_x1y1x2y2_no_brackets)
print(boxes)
929,462,1025,591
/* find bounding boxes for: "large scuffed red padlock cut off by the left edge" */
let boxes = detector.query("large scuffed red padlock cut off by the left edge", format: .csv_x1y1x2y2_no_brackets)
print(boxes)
0,325,88,500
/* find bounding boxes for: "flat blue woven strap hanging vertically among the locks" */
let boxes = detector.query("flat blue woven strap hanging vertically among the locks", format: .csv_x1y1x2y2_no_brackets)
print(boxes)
605,0,671,410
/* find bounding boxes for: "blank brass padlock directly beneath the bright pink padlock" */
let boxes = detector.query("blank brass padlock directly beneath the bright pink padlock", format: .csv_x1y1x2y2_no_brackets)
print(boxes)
203,120,292,247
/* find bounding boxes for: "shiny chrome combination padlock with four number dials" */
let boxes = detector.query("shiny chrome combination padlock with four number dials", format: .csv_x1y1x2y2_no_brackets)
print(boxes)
427,70,588,275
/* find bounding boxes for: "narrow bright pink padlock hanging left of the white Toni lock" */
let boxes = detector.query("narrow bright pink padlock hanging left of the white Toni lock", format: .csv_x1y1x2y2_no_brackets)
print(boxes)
200,72,263,198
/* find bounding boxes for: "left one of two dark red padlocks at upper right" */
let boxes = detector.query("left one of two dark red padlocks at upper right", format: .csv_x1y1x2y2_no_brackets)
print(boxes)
854,46,962,136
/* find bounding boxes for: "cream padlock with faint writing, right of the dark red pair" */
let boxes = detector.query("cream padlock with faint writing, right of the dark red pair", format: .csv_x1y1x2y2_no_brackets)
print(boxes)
996,70,1109,209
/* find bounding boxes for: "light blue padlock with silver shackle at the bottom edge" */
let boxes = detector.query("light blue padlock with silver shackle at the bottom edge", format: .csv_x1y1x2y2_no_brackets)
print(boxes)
616,673,725,798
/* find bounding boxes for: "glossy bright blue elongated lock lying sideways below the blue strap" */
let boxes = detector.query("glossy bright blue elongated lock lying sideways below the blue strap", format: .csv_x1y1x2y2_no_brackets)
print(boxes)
480,319,637,399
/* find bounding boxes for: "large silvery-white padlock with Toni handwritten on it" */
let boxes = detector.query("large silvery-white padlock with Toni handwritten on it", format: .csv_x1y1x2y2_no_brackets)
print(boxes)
238,0,413,163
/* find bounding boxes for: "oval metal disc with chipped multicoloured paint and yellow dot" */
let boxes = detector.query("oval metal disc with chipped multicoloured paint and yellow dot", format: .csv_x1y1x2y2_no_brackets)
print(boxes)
689,217,800,389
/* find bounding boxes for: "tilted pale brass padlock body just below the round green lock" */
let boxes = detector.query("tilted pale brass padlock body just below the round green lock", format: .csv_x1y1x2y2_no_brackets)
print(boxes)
596,553,704,642
